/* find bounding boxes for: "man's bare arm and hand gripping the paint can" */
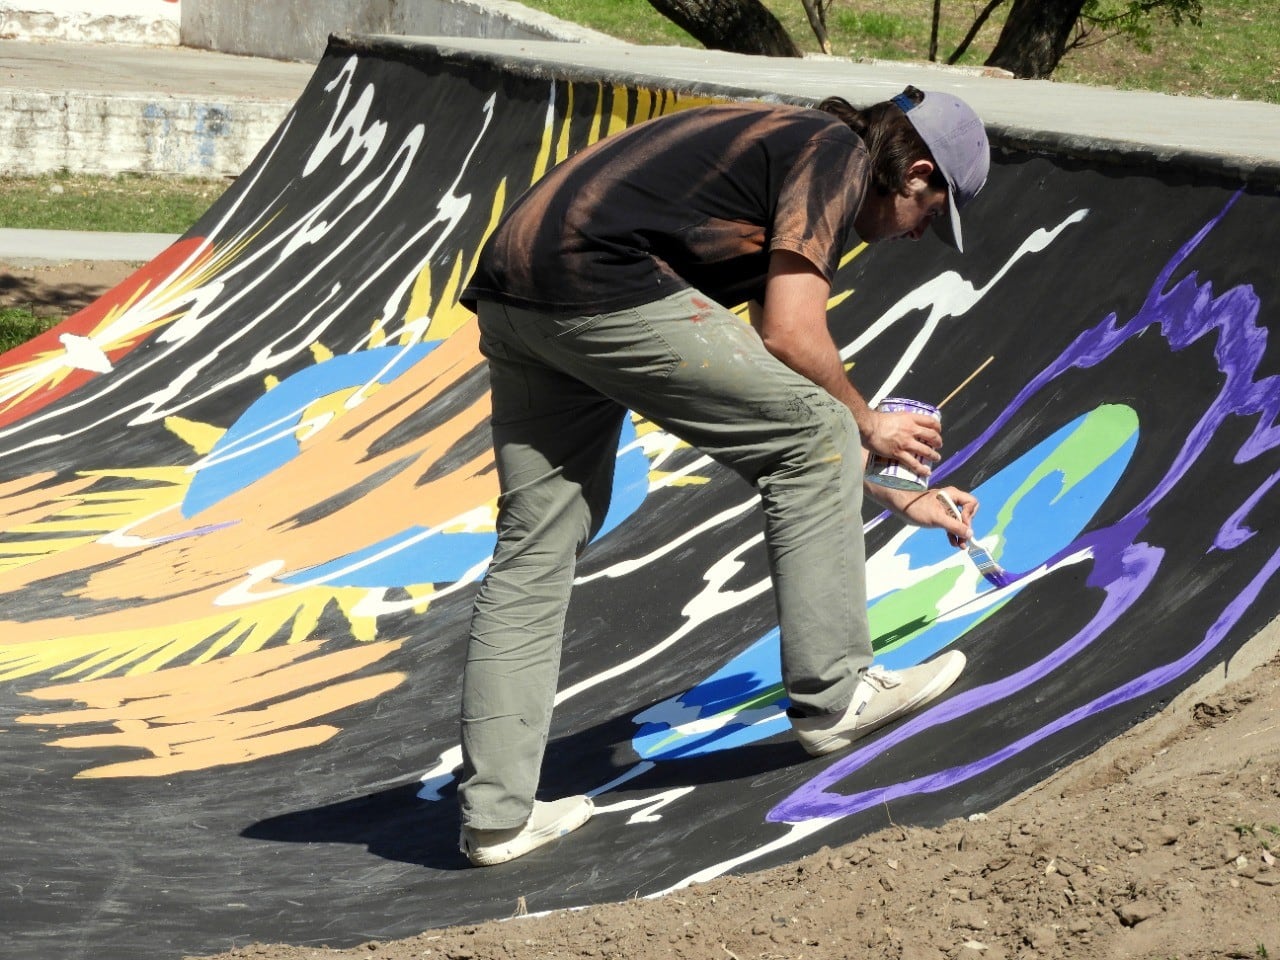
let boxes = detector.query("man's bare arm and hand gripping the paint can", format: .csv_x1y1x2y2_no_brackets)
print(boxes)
751,251,942,476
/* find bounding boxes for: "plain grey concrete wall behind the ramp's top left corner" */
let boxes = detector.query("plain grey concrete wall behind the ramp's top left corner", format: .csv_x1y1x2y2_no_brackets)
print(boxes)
182,0,620,63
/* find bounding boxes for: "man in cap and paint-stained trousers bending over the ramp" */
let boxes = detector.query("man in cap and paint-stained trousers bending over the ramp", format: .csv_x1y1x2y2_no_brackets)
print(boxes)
458,87,989,865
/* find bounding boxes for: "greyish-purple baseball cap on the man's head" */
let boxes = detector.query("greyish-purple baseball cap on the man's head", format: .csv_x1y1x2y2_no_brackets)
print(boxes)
892,92,991,252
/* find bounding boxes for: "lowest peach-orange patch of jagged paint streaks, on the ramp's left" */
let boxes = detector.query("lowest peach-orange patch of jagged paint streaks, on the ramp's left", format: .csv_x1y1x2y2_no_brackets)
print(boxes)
18,640,404,778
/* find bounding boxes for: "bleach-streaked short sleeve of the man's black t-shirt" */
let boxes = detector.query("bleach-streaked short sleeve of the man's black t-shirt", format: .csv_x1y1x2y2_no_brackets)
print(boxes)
769,131,869,280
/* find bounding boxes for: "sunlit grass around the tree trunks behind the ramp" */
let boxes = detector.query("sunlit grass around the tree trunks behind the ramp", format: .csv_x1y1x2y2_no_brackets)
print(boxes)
521,0,1280,104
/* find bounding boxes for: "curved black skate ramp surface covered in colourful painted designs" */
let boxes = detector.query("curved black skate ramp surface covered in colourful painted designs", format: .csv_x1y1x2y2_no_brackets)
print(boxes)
0,32,1280,960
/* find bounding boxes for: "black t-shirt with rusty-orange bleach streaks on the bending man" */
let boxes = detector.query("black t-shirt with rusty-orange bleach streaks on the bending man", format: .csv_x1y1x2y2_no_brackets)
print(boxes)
462,104,868,315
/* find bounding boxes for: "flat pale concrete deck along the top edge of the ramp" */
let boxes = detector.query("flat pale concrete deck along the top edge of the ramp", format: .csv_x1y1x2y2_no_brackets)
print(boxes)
350,36,1280,188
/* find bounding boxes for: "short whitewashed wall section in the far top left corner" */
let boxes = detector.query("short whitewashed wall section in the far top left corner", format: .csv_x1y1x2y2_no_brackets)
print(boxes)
0,0,180,45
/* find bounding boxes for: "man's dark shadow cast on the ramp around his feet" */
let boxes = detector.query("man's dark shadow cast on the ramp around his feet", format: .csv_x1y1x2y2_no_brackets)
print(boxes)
241,710,806,870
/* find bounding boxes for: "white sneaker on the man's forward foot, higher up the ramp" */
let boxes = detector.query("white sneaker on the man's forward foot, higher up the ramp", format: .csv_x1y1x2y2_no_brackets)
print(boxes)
791,650,965,756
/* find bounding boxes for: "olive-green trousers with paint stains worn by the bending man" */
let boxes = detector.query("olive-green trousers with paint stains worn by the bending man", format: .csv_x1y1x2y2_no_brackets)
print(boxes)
458,291,872,829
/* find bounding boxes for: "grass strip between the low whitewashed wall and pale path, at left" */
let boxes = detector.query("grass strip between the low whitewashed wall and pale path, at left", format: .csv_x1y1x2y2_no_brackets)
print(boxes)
0,173,228,233
